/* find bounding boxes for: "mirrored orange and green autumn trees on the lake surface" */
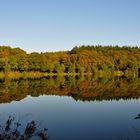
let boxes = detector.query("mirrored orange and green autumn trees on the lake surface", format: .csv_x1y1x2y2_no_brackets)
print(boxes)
0,76,140,103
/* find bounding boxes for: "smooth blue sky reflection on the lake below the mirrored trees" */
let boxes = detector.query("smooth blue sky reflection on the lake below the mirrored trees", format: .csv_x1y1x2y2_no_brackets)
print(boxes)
0,95,140,140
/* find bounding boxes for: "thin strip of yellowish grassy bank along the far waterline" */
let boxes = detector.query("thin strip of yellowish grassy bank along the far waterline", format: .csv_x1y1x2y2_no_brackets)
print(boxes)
0,71,128,79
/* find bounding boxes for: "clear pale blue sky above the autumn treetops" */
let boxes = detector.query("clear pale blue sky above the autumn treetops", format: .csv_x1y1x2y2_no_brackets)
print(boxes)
0,0,140,52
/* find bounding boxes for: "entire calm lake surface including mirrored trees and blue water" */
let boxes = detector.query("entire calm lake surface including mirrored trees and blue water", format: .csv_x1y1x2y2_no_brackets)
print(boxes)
0,77,140,140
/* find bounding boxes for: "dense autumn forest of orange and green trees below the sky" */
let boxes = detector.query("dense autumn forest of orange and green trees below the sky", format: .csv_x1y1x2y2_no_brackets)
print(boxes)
0,45,140,75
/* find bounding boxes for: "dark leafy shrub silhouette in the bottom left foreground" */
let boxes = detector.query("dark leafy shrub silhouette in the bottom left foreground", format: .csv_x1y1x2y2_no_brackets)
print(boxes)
0,116,49,140
